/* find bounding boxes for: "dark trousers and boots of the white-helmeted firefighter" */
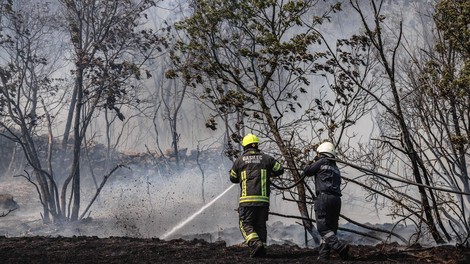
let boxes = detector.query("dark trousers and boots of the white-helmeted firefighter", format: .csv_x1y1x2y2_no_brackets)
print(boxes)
314,193,345,259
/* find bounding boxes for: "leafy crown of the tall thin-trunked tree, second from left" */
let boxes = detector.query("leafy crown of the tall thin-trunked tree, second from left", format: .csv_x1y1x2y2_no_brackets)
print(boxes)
65,0,168,120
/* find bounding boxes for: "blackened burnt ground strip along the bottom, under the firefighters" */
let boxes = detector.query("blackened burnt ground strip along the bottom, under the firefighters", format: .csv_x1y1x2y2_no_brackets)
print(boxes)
0,236,470,263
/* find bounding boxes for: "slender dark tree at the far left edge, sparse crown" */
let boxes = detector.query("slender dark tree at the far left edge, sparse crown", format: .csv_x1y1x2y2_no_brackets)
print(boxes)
0,1,66,222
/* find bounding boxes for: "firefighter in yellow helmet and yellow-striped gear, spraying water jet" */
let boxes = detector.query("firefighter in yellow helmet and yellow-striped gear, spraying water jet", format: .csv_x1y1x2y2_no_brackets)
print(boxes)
230,134,284,257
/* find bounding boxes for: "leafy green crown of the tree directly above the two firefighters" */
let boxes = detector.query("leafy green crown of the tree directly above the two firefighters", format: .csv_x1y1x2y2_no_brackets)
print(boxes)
167,0,341,138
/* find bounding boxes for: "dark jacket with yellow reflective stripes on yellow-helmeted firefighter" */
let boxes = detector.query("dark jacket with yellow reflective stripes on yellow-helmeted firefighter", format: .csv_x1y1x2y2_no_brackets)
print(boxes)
230,148,284,206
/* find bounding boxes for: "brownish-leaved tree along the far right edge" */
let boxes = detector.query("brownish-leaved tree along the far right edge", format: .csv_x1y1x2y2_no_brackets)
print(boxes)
405,1,470,242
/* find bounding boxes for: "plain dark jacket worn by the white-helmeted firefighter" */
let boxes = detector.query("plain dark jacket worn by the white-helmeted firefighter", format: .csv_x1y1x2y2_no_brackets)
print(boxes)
304,156,341,196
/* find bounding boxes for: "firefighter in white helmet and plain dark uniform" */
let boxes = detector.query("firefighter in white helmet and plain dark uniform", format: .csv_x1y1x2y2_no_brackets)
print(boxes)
303,142,349,260
